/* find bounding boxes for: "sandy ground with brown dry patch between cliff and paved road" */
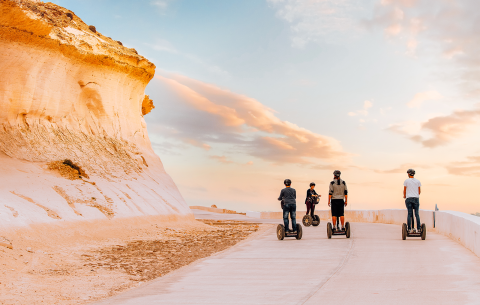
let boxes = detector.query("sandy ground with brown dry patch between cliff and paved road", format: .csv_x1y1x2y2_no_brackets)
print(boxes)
0,217,269,305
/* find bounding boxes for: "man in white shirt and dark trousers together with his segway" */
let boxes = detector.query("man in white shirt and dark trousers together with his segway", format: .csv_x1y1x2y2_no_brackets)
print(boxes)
402,168,427,240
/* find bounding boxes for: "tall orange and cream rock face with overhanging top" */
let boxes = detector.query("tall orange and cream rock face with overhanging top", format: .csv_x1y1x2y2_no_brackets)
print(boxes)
0,0,191,226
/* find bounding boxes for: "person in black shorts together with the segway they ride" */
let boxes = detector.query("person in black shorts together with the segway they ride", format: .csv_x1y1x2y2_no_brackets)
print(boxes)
327,170,350,238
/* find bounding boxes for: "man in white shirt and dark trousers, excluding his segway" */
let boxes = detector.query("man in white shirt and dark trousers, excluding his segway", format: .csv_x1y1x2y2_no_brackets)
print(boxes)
403,169,422,232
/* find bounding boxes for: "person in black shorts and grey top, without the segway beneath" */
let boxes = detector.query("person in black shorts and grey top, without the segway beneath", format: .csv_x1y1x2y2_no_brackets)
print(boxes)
328,170,348,232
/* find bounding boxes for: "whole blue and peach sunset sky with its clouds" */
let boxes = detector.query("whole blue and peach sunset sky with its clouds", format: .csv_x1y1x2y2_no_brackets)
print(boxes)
53,0,480,213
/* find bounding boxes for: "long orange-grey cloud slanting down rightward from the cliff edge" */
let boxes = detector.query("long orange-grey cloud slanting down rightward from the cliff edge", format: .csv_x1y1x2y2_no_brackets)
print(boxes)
146,71,349,164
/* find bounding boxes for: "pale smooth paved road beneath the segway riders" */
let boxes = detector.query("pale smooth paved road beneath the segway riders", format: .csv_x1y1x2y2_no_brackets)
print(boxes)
97,212,480,305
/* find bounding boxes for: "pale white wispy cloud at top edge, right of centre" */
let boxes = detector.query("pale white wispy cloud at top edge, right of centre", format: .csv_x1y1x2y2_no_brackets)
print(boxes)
267,0,359,49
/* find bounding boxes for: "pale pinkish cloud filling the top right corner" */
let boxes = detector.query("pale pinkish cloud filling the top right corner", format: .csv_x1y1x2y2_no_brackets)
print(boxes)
364,0,480,94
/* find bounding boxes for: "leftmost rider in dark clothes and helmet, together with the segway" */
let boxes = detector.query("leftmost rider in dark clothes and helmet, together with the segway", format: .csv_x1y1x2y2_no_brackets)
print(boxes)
277,179,302,240
